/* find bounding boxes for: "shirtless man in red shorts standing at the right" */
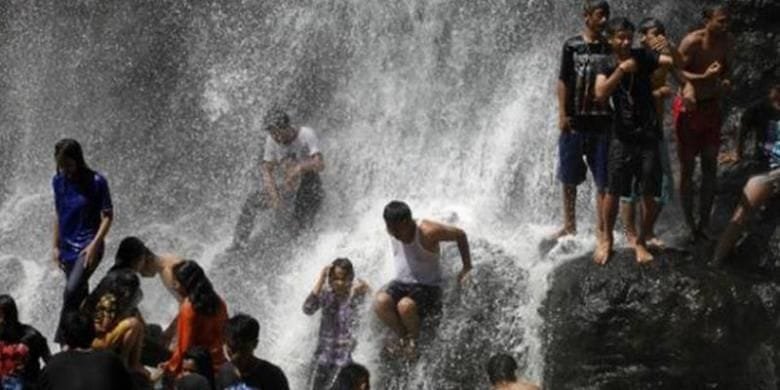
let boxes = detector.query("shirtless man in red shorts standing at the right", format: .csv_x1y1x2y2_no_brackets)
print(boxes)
673,6,734,239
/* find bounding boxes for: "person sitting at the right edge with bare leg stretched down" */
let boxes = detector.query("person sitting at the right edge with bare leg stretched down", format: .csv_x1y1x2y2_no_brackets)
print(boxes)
714,83,780,262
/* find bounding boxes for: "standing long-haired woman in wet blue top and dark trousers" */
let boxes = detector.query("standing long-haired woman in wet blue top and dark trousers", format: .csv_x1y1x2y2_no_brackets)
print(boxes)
52,138,113,342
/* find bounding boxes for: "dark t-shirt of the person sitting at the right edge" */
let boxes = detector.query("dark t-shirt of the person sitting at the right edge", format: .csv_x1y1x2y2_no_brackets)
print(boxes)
738,99,780,168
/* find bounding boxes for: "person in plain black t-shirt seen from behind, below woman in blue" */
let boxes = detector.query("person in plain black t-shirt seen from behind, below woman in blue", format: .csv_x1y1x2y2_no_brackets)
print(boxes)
38,312,133,390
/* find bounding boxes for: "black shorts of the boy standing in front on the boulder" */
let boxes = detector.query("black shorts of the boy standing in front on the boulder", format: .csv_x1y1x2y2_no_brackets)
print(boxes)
607,139,663,198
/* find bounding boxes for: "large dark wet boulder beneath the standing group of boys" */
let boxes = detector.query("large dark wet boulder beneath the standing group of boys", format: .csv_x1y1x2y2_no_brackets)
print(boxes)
542,250,780,389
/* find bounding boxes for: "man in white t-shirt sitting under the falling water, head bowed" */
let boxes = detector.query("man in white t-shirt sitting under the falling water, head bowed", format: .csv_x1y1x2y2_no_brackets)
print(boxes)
233,109,325,248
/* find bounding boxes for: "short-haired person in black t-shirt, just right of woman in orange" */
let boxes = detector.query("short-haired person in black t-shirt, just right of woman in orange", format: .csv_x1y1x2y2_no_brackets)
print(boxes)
217,314,290,390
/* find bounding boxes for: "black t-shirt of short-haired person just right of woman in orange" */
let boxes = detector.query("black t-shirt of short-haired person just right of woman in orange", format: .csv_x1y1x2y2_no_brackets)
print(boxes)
217,359,290,390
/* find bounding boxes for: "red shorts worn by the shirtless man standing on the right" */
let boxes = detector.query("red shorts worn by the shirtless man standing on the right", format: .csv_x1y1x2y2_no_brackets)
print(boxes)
672,96,722,160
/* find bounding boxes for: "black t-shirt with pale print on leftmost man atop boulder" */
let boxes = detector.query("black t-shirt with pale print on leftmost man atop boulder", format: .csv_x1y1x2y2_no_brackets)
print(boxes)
558,35,611,117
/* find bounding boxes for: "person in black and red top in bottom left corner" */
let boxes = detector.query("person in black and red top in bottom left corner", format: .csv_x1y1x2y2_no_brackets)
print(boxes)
0,295,51,390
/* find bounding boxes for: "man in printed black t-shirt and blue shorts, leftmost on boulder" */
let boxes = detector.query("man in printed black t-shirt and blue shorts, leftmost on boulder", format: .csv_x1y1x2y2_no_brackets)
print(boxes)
552,0,610,244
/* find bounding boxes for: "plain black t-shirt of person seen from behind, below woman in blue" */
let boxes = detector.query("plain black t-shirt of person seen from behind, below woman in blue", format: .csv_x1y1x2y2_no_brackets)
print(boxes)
38,351,133,390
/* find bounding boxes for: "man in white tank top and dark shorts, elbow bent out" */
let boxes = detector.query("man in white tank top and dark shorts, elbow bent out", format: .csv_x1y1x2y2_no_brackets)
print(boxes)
374,201,471,354
